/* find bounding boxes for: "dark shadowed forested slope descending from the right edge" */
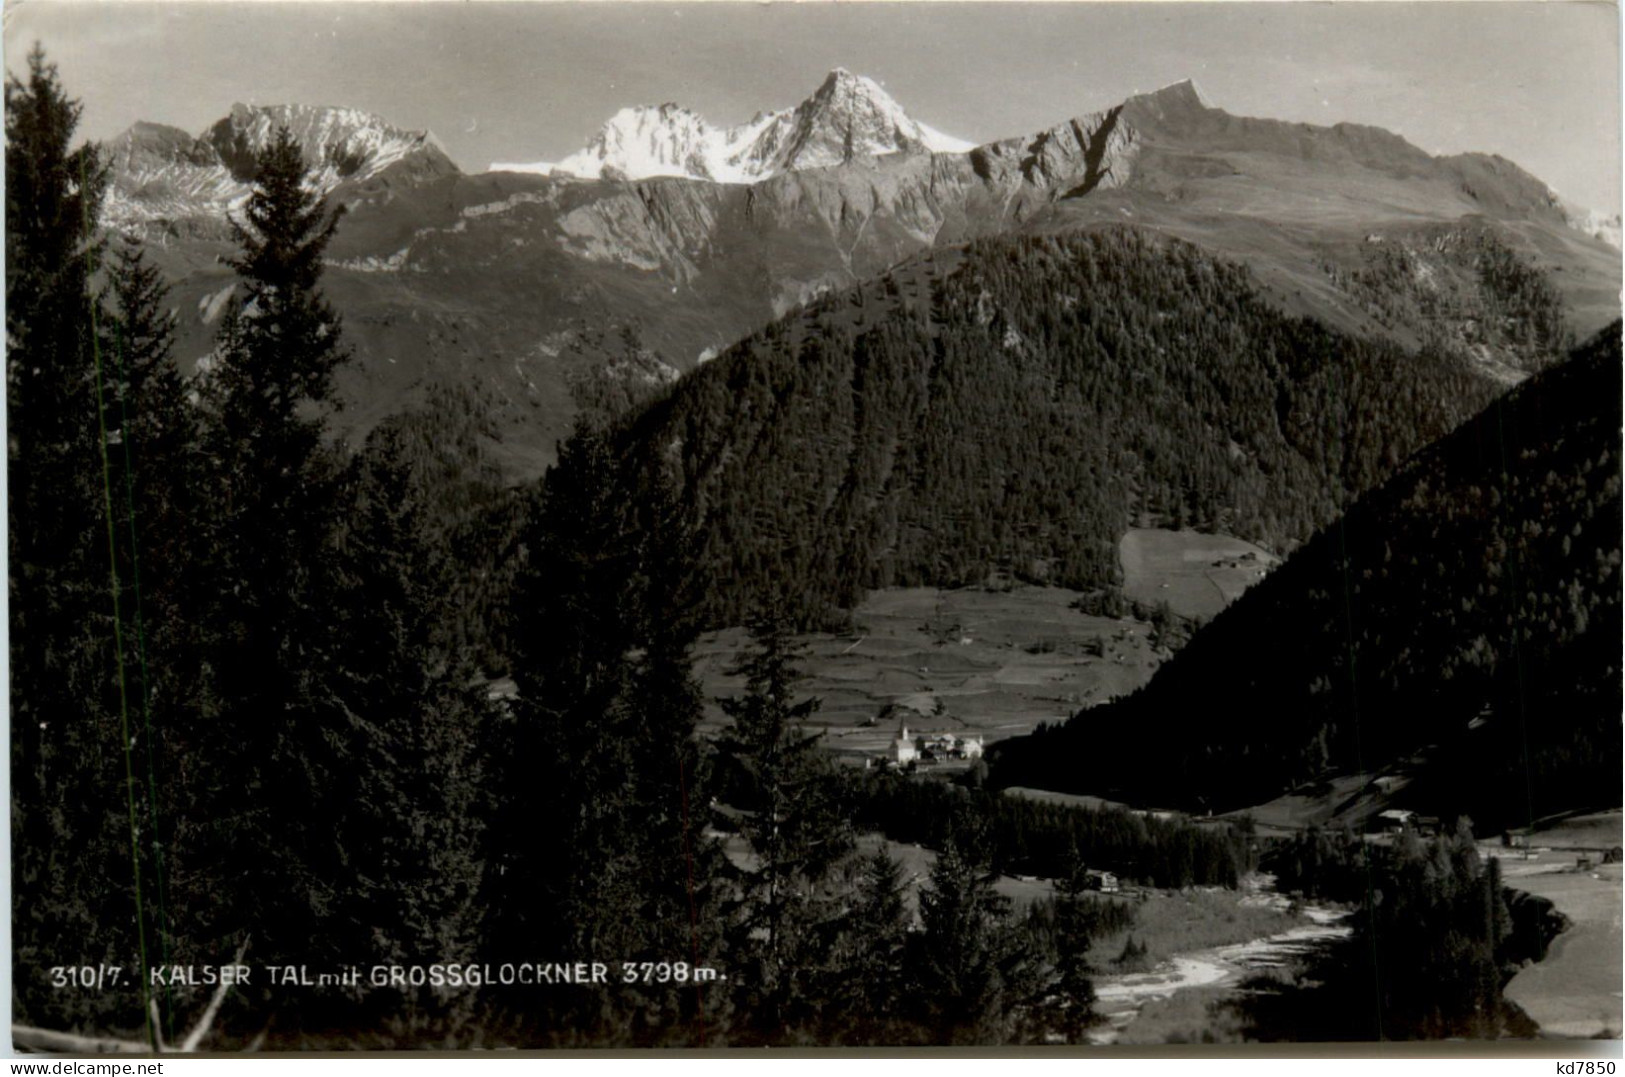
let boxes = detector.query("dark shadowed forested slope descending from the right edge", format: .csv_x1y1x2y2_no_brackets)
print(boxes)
995,323,1620,825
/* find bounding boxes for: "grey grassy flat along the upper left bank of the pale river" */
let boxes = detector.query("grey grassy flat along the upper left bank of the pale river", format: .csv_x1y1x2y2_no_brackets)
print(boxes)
1089,890,1303,973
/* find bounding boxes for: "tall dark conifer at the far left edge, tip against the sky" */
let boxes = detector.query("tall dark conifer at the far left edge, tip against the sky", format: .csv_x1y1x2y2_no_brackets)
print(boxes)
5,45,145,1030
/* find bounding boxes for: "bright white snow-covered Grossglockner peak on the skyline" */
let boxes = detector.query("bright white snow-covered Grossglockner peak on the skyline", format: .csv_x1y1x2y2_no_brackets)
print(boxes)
491,68,973,184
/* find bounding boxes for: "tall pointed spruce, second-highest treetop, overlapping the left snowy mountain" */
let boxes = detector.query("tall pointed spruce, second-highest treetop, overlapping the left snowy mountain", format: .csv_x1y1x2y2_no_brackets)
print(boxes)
192,128,354,1020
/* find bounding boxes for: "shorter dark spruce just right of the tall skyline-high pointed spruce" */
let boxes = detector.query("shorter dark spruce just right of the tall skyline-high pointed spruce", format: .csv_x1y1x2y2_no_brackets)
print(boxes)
330,416,496,1046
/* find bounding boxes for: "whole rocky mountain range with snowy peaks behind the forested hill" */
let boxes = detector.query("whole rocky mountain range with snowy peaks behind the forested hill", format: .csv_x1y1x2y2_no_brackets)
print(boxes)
104,70,1620,479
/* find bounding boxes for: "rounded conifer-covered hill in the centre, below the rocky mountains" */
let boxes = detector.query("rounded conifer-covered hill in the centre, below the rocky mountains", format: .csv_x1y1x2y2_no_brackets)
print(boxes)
622,229,1521,622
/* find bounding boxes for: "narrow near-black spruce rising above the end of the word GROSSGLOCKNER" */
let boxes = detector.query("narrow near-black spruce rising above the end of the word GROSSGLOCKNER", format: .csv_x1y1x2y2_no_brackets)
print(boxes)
492,430,639,947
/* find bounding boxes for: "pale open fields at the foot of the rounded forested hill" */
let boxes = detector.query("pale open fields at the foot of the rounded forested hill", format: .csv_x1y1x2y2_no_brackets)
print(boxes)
694,528,1276,753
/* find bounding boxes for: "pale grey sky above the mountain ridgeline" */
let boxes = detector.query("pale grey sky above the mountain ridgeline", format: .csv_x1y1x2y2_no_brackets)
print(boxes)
5,0,1620,211
